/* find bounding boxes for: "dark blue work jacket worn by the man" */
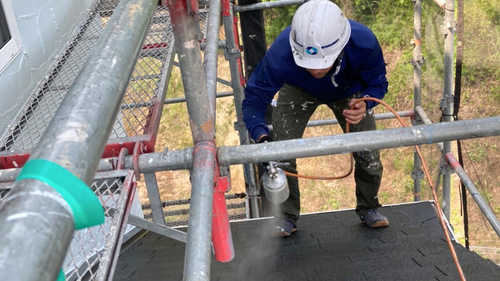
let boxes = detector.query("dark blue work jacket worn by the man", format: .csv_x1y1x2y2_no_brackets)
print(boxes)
242,20,388,140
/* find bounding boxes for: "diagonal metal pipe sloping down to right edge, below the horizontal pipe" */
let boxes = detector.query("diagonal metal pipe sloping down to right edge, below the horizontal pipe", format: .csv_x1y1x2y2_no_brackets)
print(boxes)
446,152,500,237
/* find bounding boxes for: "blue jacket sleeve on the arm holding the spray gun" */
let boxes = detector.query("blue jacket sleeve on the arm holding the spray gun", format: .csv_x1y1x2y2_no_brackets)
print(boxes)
242,54,284,140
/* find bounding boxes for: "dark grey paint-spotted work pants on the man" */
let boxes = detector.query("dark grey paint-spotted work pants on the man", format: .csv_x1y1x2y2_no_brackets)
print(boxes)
272,84,383,225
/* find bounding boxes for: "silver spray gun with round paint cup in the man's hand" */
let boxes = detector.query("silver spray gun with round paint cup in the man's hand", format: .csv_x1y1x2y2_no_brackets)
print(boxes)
262,161,290,204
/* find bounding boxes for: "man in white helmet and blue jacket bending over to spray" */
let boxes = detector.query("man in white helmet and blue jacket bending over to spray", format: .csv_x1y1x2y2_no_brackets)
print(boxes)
242,0,389,236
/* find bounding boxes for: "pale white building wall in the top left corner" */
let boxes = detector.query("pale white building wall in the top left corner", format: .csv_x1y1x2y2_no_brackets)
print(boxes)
0,0,96,136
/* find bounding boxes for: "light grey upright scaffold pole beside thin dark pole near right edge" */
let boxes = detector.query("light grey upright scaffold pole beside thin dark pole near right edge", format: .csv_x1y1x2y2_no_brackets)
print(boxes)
441,0,456,221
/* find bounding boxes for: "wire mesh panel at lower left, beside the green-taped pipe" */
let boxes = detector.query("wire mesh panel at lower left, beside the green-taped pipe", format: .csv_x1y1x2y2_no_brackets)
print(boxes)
63,168,135,281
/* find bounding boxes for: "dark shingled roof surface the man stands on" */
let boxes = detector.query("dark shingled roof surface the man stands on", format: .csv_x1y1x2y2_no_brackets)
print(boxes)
114,202,500,281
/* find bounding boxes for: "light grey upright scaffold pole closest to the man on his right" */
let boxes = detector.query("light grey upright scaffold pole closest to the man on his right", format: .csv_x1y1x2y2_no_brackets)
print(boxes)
413,0,424,201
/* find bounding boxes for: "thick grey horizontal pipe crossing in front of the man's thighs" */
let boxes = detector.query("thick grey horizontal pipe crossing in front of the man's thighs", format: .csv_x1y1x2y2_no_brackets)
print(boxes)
219,116,500,166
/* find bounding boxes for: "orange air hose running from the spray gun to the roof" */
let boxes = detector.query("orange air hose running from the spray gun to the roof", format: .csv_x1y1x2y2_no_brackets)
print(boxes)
285,97,465,281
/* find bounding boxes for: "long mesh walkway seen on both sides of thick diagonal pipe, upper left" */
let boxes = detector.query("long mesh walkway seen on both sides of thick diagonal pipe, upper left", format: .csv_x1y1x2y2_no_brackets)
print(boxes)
0,0,173,154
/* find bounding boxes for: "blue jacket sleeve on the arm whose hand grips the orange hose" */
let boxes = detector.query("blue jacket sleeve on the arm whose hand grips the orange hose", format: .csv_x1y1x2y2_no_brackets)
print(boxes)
359,40,389,108
